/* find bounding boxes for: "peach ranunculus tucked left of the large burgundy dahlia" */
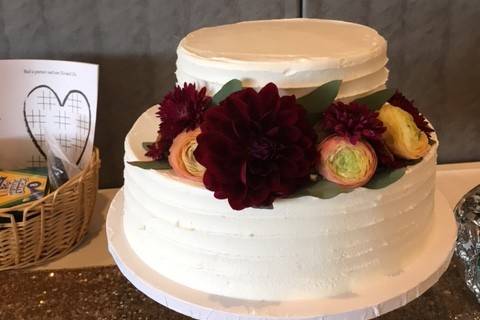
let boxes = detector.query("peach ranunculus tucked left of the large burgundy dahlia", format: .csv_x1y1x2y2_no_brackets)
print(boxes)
168,128,205,182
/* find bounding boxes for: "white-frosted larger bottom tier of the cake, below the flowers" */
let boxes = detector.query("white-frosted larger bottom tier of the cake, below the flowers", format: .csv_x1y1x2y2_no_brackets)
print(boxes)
124,108,437,300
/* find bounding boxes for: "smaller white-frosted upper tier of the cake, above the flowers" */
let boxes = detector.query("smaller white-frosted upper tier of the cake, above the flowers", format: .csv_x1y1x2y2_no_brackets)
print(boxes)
176,19,388,99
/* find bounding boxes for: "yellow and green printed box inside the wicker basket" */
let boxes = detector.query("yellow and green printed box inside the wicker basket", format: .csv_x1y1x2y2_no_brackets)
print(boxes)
0,169,47,208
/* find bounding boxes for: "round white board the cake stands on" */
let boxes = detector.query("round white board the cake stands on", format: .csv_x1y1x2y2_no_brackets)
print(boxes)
106,189,457,320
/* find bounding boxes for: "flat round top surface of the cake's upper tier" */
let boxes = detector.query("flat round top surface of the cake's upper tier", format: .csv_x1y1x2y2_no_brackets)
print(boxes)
180,19,386,66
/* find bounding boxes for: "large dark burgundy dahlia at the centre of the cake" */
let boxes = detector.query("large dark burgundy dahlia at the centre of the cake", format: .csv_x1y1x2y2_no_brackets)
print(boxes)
194,83,316,210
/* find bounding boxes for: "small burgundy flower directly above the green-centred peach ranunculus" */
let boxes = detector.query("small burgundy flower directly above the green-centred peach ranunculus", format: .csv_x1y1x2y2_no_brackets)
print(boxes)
322,101,386,144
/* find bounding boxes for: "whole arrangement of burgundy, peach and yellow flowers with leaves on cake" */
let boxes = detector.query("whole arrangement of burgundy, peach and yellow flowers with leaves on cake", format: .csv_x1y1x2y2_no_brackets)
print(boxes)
129,79,435,210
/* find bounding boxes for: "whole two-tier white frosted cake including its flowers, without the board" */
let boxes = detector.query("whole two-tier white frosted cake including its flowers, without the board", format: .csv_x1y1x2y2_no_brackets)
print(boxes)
124,19,438,300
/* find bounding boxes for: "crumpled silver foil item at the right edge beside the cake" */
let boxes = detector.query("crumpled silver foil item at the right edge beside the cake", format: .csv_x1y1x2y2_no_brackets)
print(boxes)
454,185,480,302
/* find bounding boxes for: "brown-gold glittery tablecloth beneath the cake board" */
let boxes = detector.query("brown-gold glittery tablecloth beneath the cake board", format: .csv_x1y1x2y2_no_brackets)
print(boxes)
0,259,480,320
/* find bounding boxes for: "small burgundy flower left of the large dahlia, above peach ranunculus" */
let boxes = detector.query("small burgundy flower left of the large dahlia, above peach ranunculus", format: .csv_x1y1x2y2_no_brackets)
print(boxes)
146,83,211,160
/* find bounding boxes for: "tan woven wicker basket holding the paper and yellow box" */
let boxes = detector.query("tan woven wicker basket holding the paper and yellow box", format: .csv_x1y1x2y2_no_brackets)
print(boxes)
0,149,100,270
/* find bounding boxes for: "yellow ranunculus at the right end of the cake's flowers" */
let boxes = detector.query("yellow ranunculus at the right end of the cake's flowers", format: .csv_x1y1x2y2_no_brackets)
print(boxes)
378,103,430,160
